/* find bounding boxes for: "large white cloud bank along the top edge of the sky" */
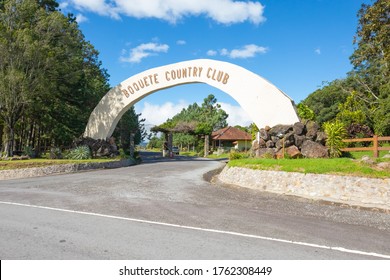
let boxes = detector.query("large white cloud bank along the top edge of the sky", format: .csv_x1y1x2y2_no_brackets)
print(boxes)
69,0,265,24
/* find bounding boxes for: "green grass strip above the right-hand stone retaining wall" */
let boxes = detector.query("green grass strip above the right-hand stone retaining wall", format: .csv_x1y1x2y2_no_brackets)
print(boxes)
228,158,390,178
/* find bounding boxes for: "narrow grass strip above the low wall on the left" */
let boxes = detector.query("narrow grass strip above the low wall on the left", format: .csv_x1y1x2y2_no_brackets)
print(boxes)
0,158,120,170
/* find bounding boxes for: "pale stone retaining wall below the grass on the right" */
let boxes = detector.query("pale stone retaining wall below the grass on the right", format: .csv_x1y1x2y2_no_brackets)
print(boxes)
218,166,390,210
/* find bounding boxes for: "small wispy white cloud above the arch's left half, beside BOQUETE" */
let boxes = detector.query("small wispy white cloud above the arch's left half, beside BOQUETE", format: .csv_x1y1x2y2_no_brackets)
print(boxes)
120,43,169,63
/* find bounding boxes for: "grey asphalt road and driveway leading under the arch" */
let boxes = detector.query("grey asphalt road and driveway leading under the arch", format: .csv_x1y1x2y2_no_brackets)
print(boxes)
0,153,390,259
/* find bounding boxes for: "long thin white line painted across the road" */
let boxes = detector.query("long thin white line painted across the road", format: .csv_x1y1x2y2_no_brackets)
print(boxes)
0,201,390,259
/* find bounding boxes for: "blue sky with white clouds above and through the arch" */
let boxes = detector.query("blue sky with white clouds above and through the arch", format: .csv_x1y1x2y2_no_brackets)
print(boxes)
59,0,371,129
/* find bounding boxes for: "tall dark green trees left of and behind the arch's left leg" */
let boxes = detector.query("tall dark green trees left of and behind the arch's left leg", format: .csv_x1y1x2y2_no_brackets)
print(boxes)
0,0,144,156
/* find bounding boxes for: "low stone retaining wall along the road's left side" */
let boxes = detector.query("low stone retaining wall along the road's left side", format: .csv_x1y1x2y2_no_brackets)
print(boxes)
0,159,135,180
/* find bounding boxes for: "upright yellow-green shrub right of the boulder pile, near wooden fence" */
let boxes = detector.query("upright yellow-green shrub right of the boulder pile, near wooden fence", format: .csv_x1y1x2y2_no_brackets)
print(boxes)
323,121,347,158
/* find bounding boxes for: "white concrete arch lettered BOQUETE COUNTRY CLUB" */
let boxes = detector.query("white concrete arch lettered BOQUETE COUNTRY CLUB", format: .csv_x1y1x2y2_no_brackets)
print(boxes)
84,59,299,139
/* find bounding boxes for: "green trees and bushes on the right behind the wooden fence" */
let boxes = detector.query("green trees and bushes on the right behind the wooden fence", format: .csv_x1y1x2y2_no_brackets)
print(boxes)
298,0,390,137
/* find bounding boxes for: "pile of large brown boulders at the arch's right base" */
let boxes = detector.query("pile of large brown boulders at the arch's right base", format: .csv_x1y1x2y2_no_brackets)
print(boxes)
252,121,329,158
